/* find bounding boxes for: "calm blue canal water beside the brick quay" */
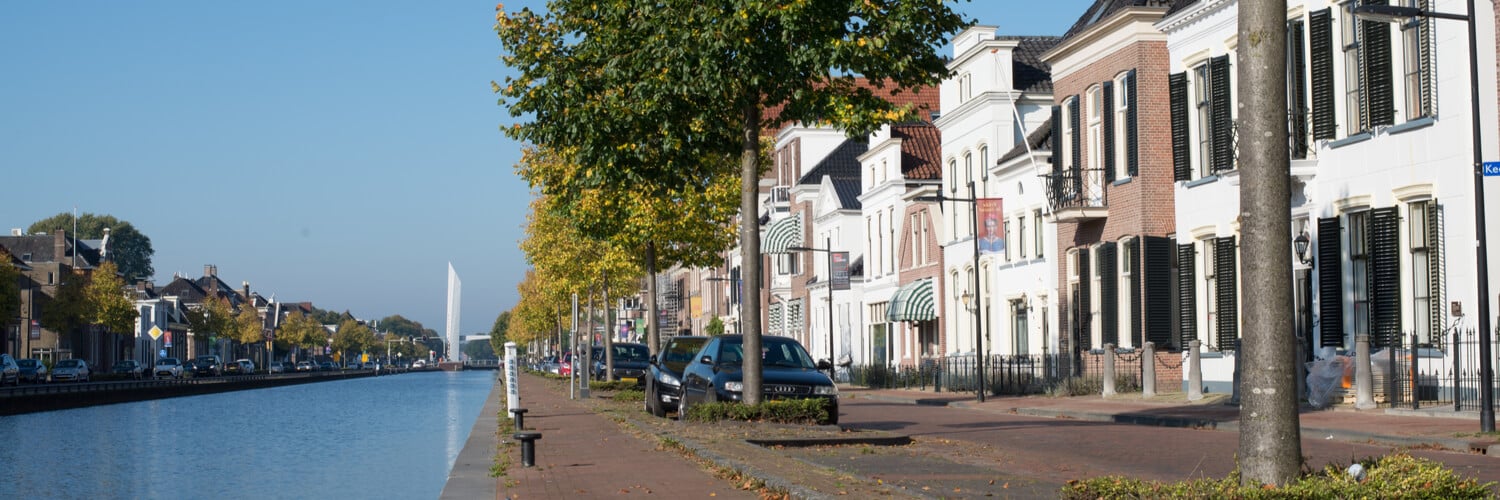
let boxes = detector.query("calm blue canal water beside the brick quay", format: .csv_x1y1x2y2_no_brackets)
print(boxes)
0,371,495,498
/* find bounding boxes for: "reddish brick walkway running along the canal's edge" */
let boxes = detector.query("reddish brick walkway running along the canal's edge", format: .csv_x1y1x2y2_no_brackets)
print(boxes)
497,374,756,498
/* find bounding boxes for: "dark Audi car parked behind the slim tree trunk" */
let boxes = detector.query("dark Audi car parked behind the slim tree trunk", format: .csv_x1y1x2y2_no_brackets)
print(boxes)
678,335,839,423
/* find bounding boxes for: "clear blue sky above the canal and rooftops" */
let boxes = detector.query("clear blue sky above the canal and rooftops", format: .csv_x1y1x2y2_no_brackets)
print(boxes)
0,0,1092,333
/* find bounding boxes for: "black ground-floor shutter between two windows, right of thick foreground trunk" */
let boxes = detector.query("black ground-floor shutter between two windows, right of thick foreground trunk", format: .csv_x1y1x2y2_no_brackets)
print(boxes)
1370,207,1401,347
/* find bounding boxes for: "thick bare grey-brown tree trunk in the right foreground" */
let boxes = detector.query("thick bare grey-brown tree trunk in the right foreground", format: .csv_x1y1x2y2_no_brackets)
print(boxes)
1236,0,1302,485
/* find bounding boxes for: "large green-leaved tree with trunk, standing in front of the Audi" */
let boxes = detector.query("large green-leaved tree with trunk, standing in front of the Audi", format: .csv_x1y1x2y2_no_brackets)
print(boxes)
494,0,966,404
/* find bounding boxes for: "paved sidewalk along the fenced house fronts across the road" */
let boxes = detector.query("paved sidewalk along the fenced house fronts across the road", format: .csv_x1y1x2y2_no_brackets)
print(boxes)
839,386,1500,456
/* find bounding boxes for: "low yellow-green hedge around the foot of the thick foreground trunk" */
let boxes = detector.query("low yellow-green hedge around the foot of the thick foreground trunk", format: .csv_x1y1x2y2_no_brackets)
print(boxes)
1062,453,1494,500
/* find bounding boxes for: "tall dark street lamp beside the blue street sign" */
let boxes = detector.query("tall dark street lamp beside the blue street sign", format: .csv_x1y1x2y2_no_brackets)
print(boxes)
1355,0,1496,432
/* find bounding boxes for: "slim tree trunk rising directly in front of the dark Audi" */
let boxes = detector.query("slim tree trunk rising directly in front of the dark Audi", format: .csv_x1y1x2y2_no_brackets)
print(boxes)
740,104,761,404
